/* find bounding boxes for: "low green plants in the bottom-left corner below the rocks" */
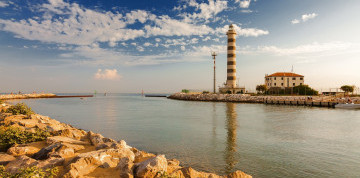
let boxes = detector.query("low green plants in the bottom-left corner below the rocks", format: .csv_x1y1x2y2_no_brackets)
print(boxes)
0,165,59,178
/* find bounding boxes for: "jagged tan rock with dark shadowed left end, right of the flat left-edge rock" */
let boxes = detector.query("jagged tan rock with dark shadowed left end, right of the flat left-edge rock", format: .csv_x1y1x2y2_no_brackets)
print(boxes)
32,142,85,160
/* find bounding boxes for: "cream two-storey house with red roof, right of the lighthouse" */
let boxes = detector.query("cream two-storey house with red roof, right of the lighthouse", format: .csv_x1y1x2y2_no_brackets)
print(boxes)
265,72,304,88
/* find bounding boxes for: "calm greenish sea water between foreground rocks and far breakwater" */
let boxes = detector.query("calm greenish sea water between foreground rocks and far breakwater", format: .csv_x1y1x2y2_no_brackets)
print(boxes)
8,94,360,177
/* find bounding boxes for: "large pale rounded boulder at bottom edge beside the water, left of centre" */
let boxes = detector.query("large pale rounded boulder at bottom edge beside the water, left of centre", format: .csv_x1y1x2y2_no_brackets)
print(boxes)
134,155,167,177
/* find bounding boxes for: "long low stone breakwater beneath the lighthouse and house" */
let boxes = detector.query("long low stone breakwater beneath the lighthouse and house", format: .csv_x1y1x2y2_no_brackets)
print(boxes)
168,93,360,103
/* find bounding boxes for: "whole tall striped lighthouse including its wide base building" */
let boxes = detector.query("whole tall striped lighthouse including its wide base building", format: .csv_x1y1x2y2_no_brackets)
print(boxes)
219,24,245,94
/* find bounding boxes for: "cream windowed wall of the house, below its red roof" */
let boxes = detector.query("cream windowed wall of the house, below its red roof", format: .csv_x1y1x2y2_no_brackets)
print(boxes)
265,77,304,88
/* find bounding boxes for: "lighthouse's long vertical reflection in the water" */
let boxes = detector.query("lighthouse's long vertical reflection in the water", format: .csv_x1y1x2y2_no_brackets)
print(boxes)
225,103,238,173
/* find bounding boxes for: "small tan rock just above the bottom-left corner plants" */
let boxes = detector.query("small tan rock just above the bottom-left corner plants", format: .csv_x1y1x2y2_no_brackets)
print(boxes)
6,155,37,174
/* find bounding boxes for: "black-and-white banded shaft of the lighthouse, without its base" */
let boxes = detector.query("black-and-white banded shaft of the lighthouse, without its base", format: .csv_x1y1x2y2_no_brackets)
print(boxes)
226,24,236,88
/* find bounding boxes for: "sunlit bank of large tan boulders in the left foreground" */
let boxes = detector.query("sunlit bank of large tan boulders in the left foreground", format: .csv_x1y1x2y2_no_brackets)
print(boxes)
0,104,251,178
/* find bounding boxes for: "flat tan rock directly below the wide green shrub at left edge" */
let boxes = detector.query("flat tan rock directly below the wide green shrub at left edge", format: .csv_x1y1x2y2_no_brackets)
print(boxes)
7,141,45,156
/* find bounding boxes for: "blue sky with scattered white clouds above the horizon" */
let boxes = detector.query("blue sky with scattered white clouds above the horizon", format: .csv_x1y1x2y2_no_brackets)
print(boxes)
0,0,360,93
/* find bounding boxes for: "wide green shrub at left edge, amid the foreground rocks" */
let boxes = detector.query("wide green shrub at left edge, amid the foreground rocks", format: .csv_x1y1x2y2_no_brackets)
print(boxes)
0,126,50,151
